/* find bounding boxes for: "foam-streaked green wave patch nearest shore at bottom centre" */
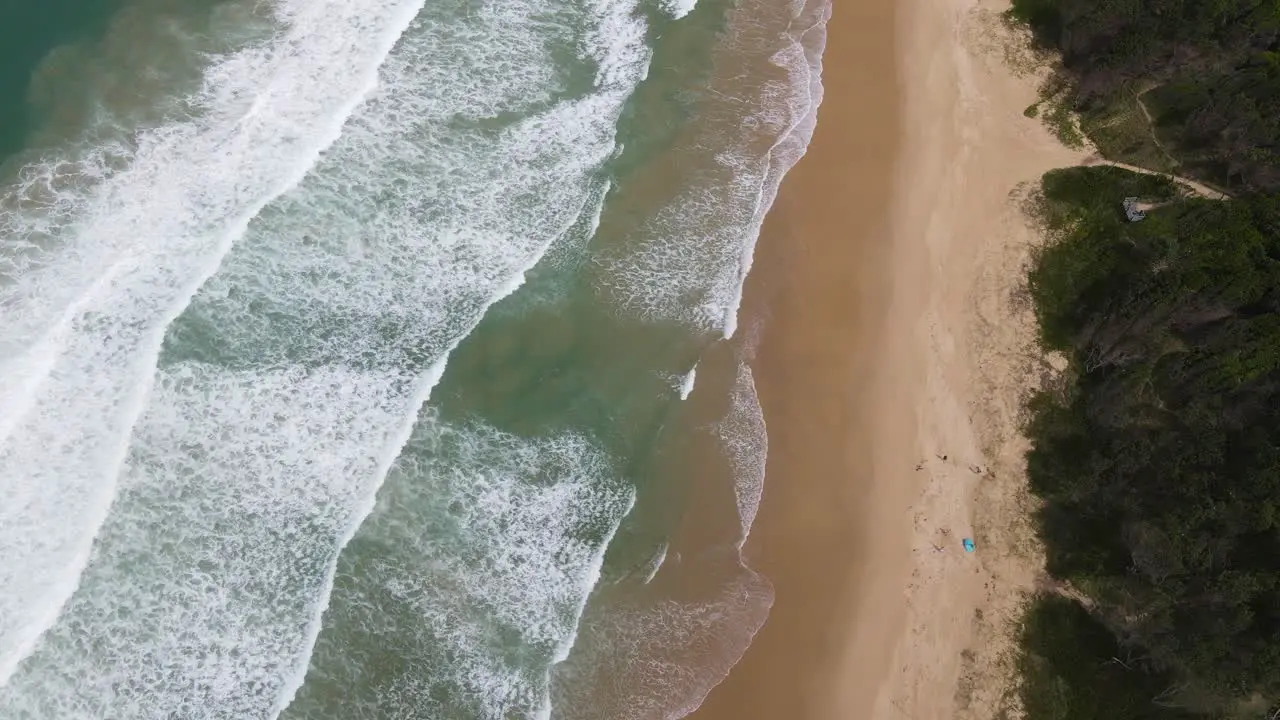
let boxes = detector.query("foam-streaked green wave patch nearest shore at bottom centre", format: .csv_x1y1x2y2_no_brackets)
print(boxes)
288,418,631,720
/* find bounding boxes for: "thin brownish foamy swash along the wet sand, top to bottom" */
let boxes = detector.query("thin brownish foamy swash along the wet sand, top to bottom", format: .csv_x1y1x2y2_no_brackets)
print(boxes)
554,0,831,720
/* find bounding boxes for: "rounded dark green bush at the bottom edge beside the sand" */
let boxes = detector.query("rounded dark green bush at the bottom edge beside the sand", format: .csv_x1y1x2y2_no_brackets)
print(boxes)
1019,594,1193,720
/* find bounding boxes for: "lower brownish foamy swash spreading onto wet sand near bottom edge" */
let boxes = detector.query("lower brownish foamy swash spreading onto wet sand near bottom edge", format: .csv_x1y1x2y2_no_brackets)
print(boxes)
552,351,773,720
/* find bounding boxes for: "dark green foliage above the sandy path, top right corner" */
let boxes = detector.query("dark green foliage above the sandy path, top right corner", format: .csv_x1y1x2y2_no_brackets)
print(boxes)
1014,0,1280,190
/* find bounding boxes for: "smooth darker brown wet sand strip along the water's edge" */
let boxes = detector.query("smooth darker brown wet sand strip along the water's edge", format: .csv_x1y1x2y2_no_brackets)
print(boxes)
692,0,914,720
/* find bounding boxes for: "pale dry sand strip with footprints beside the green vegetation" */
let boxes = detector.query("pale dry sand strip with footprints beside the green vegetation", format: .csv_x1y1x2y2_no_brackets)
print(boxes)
880,0,1085,720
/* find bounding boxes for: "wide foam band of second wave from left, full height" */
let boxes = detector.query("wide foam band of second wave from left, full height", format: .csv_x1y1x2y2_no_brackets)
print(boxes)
0,1,648,707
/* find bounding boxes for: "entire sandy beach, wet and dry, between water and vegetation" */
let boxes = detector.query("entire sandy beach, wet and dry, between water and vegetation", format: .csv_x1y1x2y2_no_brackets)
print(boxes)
694,0,1084,720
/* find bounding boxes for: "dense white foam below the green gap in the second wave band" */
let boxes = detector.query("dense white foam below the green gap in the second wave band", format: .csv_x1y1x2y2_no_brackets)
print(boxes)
0,365,414,719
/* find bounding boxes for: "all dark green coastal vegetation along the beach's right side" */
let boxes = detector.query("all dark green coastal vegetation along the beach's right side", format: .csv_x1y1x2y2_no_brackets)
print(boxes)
1010,0,1280,720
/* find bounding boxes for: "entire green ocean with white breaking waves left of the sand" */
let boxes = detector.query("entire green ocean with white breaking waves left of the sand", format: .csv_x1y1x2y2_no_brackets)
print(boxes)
0,0,829,720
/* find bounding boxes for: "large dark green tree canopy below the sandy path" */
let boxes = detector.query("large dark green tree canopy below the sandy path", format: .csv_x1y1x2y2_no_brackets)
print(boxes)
1028,168,1280,720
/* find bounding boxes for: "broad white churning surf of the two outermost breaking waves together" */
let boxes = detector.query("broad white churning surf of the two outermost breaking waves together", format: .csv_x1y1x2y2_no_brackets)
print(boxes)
0,1,645,719
